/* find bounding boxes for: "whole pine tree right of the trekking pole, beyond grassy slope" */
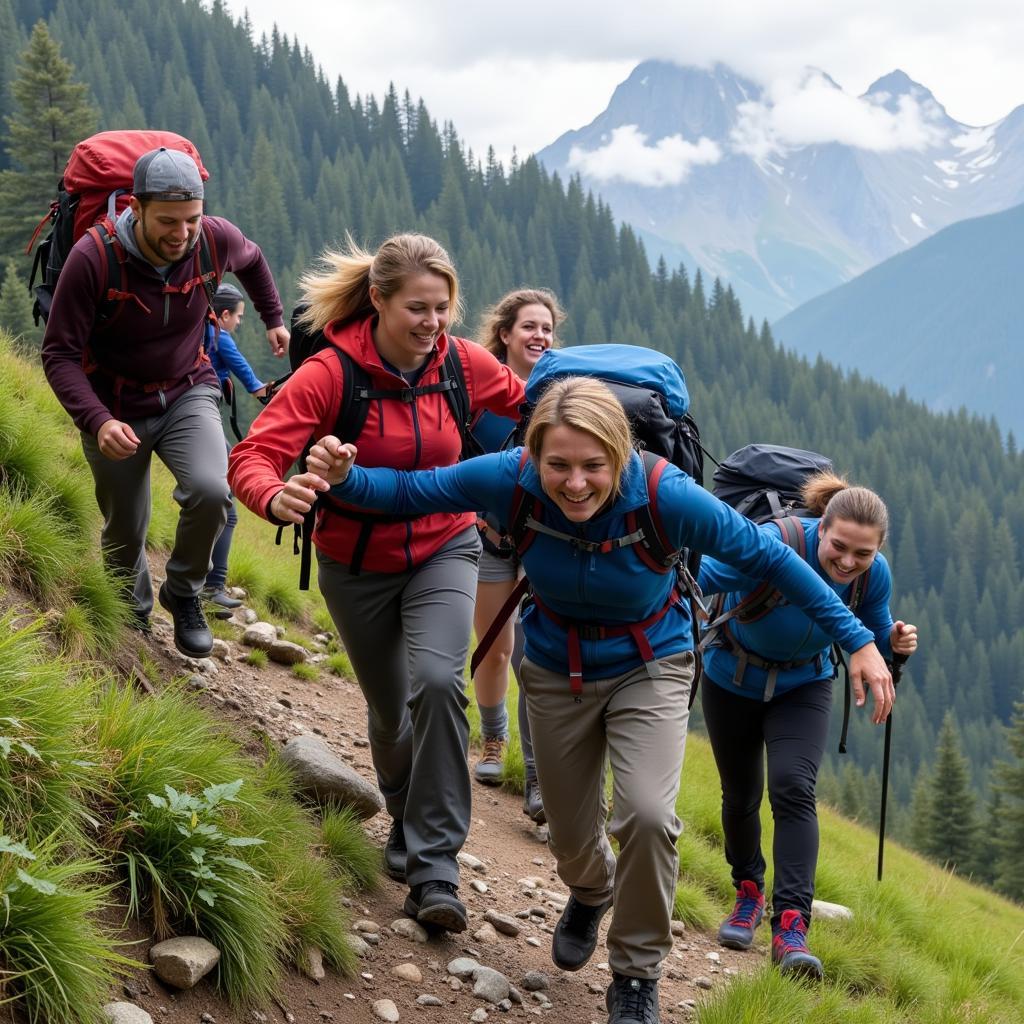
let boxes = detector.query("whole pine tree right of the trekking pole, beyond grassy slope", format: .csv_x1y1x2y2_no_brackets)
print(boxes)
924,712,978,872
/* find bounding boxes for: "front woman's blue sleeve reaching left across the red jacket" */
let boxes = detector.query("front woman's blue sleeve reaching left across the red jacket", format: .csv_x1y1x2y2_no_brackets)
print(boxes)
331,449,522,525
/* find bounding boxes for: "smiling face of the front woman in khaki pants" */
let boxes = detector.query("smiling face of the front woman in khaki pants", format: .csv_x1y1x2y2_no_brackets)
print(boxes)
538,424,615,522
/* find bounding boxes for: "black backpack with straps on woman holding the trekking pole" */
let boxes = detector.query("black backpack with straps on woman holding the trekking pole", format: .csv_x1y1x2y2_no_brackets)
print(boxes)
700,444,871,754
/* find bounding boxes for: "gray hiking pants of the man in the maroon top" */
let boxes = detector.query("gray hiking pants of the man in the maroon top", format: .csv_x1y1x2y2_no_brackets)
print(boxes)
82,384,230,615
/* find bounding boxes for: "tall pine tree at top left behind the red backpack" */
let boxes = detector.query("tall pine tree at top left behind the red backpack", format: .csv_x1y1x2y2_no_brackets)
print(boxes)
0,22,96,255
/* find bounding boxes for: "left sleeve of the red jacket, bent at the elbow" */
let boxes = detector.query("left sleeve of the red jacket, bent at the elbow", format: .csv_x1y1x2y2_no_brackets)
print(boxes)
227,351,341,519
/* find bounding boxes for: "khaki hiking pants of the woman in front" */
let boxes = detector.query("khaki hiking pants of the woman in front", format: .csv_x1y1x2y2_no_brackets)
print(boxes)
520,651,694,978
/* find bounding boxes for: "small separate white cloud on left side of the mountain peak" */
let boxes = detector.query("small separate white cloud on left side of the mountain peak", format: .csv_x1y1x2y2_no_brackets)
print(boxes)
568,125,722,187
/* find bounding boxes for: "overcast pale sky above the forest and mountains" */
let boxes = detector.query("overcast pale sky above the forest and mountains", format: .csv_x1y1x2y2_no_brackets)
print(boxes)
226,0,1024,161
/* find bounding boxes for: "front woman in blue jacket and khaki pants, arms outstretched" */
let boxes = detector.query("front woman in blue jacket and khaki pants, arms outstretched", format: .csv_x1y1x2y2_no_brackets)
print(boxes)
287,377,894,1024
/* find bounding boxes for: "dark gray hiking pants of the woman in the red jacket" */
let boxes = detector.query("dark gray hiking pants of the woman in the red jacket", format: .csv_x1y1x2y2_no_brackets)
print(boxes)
316,527,480,886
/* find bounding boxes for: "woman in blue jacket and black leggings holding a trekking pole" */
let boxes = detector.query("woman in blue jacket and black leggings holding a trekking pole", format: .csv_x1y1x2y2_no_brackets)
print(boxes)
699,473,918,978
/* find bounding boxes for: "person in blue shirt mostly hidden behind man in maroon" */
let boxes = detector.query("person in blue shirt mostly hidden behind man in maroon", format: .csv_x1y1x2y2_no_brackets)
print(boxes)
203,285,266,618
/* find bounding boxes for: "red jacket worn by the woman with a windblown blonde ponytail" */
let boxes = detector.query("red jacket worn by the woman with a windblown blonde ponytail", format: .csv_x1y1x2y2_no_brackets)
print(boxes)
227,317,523,572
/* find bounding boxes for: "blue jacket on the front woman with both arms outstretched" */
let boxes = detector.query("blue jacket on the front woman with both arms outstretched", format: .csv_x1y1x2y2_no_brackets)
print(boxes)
332,449,873,680
